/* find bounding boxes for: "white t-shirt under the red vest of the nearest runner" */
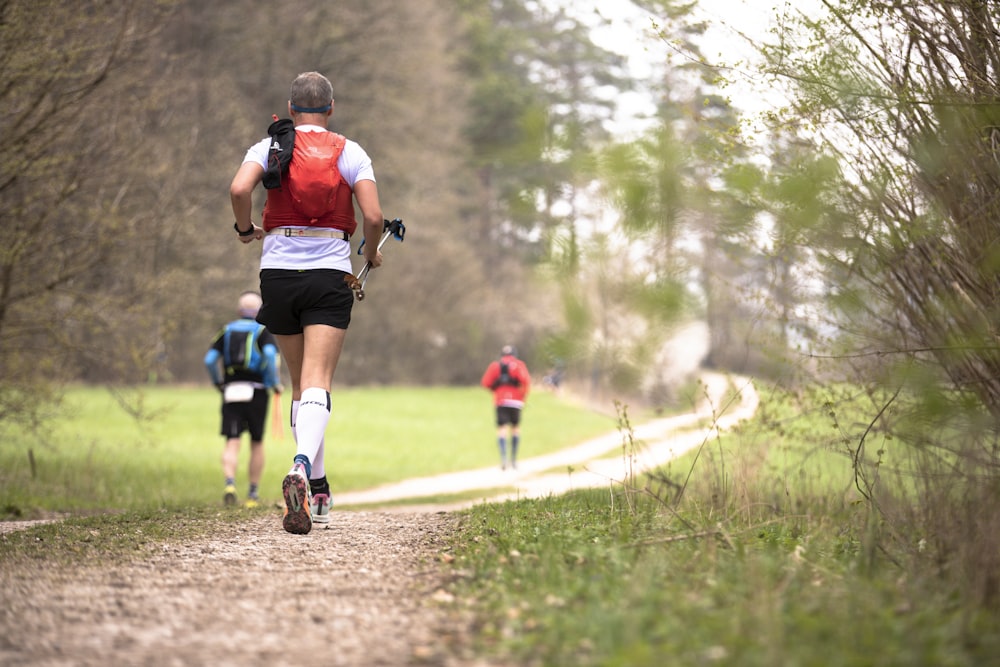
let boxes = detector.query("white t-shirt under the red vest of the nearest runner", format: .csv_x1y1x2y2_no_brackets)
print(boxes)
243,125,375,273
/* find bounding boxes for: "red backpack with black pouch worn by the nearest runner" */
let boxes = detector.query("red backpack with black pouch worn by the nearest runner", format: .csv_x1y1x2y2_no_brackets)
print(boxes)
263,118,347,219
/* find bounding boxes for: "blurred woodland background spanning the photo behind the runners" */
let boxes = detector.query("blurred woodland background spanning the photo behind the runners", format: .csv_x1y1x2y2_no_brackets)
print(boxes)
0,0,1000,434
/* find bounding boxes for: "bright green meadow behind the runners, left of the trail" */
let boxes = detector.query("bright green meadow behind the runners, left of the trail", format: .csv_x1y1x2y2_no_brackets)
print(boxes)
0,386,615,518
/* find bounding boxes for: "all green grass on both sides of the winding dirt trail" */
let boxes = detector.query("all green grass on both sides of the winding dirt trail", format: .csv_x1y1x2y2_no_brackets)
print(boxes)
0,378,1000,667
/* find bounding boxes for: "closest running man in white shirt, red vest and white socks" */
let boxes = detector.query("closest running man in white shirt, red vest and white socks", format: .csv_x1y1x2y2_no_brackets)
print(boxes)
229,72,384,534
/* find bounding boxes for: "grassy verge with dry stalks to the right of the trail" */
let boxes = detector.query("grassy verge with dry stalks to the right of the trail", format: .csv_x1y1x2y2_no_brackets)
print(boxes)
453,384,1000,667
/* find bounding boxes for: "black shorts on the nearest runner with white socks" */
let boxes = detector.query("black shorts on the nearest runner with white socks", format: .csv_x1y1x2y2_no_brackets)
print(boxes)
257,269,354,336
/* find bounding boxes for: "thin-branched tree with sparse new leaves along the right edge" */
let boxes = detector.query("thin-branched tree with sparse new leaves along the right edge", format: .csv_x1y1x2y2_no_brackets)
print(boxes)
770,0,1000,419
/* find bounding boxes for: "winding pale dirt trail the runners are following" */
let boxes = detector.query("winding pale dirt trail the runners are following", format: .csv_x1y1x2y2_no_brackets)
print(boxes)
0,377,756,667
